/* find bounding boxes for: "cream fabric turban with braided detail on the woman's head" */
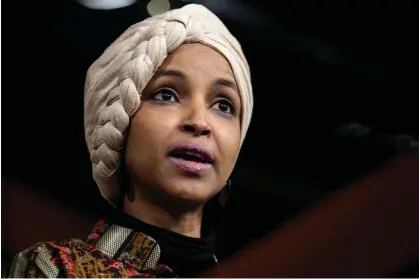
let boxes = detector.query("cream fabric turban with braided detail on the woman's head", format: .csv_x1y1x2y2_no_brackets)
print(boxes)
84,4,253,204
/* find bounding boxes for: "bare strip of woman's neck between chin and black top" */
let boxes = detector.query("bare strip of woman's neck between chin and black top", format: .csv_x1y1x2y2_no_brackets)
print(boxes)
124,193,203,238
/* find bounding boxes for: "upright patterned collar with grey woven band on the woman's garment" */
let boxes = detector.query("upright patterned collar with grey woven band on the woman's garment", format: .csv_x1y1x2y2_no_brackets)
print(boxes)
86,220,161,271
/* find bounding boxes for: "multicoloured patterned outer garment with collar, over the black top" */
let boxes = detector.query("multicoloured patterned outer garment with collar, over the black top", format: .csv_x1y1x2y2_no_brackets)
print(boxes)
9,220,177,278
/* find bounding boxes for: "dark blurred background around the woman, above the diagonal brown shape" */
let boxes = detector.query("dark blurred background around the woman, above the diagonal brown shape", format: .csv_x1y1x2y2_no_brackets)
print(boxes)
1,0,419,278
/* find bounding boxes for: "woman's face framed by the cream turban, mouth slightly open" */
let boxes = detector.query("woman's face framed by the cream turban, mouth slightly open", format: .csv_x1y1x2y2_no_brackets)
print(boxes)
125,43,241,206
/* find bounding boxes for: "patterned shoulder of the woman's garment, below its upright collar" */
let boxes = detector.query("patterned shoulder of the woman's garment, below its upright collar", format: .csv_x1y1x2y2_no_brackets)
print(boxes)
8,239,175,278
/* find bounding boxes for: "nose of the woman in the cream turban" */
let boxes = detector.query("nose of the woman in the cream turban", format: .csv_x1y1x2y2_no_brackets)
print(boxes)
181,105,212,137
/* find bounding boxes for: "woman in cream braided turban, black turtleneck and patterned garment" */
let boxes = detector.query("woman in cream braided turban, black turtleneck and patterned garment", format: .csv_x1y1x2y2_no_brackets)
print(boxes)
10,5,253,277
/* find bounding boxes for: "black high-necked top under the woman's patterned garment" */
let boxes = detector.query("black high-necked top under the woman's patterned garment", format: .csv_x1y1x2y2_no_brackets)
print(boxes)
111,210,216,277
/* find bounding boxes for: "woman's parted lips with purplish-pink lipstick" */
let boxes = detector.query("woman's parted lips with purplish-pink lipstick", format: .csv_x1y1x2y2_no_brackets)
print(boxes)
168,143,214,175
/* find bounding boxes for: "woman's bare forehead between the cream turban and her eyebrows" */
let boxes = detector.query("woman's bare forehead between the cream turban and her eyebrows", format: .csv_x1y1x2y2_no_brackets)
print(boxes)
160,43,234,80
